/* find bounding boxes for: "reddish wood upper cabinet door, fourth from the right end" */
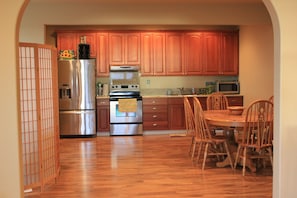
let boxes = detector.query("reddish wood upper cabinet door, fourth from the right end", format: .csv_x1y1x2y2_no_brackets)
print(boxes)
165,32,184,75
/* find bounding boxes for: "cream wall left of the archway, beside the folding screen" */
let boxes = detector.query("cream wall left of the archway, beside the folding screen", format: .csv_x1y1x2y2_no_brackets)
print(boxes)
0,0,23,198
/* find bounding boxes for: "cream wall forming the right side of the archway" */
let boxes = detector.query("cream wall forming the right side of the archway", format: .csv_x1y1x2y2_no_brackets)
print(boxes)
267,0,297,198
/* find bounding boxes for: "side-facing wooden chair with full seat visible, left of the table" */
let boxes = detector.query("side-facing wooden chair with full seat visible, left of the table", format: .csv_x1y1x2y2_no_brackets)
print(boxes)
193,97,233,170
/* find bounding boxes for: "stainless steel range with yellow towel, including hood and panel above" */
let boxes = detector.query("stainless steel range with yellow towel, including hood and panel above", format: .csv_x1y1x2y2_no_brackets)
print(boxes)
109,66,143,135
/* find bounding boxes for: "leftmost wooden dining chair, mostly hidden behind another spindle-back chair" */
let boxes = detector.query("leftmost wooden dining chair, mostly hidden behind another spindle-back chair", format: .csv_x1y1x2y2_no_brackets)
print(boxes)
184,96,196,159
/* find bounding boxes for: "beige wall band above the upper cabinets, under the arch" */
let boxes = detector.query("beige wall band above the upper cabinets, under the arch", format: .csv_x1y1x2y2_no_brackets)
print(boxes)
20,0,270,43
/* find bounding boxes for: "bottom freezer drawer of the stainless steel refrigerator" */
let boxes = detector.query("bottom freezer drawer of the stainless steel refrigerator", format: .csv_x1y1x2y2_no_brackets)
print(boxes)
59,110,96,136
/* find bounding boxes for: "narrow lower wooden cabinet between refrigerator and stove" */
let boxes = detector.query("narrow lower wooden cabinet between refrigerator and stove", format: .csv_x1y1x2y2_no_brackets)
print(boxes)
96,98,110,132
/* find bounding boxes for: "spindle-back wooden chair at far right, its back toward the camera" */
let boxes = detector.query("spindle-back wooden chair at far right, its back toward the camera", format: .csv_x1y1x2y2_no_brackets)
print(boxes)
234,100,273,176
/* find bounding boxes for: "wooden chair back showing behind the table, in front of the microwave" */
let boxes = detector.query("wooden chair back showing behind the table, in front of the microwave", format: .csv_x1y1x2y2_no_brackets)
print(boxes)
206,92,229,110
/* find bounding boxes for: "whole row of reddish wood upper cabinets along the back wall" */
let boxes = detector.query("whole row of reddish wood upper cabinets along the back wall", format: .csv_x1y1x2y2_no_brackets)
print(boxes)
57,31,239,77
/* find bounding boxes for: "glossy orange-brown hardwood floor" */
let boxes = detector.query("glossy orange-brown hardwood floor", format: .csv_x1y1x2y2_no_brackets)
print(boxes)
26,135,272,198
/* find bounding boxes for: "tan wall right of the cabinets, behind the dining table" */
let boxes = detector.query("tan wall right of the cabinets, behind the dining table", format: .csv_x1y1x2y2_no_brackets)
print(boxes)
239,25,274,106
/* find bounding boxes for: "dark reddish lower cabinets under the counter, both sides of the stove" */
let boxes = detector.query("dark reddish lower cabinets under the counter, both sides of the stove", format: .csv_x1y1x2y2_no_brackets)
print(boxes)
96,95,243,132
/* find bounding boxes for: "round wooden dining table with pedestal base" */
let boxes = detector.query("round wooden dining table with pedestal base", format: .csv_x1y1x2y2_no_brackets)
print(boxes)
204,110,256,172
